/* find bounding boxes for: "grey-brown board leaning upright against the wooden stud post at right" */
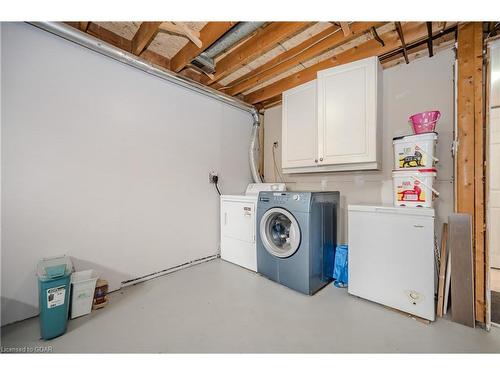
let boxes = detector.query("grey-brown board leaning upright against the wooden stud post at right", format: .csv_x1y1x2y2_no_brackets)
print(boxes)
448,214,476,327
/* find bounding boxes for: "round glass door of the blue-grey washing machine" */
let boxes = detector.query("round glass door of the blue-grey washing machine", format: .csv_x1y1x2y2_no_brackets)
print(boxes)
259,207,300,258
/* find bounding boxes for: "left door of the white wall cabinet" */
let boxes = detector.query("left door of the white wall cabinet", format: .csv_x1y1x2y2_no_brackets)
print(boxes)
281,80,318,168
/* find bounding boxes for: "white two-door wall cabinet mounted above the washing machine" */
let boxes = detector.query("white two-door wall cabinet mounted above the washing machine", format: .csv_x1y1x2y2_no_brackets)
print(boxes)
282,57,382,173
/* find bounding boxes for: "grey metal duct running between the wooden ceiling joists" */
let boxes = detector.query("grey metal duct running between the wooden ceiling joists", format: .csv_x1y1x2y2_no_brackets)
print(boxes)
192,22,265,74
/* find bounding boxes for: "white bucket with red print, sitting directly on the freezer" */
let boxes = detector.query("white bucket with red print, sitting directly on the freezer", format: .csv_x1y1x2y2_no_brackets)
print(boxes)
392,168,439,207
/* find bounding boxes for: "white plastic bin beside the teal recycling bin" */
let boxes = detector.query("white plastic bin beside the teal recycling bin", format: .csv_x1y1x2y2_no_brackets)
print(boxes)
71,270,98,319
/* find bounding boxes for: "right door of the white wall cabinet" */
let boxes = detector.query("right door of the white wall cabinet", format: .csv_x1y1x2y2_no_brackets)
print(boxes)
318,57,380,165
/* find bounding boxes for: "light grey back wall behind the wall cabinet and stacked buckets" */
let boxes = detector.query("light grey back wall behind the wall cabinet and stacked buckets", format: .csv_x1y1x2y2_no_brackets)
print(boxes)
264,50,454,242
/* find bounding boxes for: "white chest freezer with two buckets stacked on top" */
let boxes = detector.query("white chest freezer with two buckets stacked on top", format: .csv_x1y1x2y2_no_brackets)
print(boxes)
348,205,435,321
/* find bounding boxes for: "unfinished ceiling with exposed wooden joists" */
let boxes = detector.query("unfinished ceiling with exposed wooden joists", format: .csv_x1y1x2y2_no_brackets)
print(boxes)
68,21,464,108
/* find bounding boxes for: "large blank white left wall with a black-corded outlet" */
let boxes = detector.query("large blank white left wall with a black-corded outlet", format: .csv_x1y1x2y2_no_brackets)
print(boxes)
1,23,252,324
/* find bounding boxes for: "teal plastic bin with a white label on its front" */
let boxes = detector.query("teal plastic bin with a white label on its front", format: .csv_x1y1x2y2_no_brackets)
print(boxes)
37,256,73,340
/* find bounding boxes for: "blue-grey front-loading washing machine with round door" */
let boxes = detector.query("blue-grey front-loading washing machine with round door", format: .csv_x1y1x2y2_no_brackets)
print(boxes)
257,191,340,295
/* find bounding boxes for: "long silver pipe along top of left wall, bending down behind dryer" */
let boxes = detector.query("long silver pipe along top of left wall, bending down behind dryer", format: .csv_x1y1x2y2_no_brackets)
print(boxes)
28,22,262,182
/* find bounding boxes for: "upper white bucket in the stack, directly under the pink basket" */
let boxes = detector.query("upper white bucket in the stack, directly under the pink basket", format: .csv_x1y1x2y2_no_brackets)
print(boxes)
392,133,439,170
